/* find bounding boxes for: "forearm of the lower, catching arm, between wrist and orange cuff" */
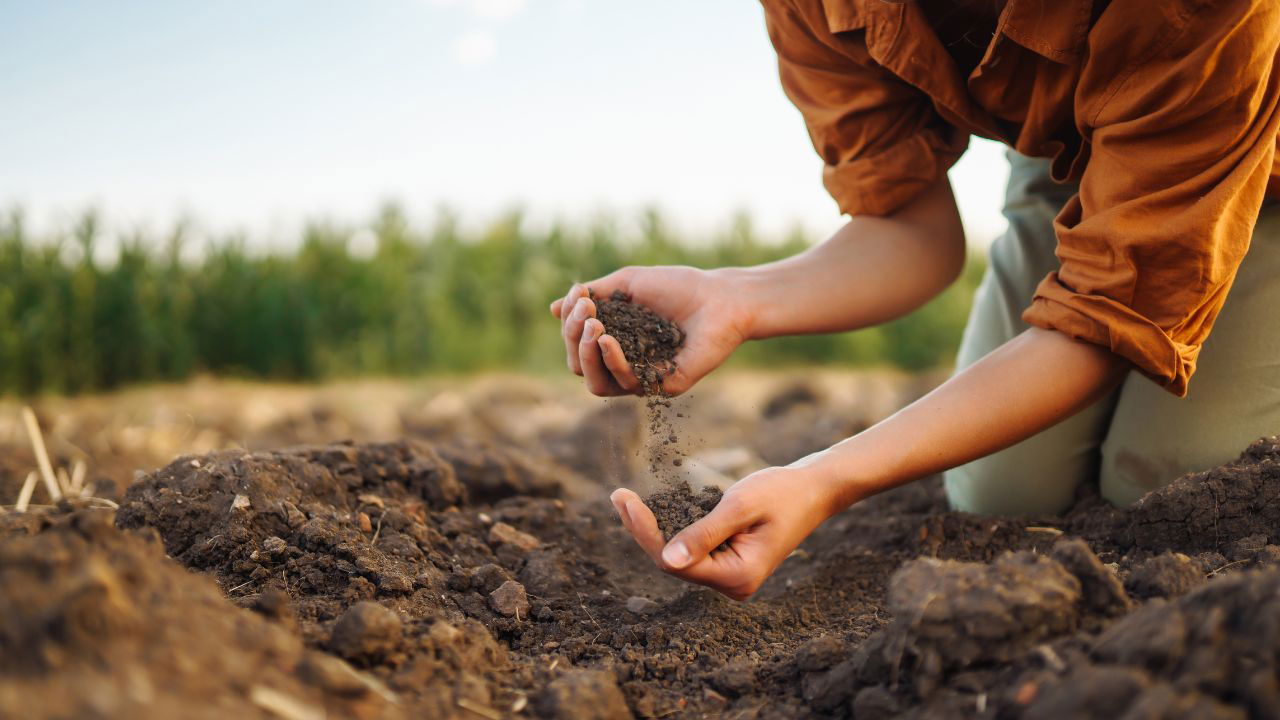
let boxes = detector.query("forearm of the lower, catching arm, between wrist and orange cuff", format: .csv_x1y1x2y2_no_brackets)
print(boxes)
801,328,1129,511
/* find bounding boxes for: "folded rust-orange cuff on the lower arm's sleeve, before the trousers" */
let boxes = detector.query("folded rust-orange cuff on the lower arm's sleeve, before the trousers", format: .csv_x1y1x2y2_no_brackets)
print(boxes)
1023,273,1201,397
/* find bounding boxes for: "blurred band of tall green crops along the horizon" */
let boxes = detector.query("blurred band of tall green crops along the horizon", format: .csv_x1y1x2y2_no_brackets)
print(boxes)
0,202,982,395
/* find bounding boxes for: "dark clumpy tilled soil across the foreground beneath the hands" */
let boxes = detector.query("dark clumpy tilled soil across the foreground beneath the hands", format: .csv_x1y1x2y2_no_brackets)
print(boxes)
0,379,1280,720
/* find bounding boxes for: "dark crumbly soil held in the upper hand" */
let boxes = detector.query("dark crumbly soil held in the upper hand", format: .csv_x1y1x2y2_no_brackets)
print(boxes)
593,290,685,395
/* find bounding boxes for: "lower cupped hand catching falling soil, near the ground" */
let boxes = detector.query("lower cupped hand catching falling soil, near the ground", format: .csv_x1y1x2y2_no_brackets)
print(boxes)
609,465,840,600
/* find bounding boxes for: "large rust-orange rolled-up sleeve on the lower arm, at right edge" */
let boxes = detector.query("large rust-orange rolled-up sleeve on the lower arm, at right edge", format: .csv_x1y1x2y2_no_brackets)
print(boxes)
1023,0,1280,396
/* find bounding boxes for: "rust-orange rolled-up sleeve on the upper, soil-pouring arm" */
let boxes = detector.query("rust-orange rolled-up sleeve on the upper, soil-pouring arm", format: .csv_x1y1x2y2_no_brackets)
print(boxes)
762,0,969,215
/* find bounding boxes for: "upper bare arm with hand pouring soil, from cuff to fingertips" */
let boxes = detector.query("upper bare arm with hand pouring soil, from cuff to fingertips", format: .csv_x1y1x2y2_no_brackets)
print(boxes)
550,177,965,396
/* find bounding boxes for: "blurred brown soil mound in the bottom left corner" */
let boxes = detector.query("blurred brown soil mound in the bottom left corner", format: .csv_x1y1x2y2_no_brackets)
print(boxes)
0,510,401,719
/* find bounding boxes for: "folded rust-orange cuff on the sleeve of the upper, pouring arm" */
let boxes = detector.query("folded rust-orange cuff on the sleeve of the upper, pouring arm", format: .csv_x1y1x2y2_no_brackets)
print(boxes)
822,128,969,215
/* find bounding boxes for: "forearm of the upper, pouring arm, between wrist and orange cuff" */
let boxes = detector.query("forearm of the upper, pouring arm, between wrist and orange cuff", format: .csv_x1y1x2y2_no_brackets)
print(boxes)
728,178,965,338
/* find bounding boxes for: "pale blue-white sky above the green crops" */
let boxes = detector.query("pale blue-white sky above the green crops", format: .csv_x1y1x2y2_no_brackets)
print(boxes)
0,0,1007,243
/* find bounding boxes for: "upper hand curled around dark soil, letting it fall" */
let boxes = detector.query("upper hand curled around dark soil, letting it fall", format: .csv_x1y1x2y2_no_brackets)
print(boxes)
552,266,754,396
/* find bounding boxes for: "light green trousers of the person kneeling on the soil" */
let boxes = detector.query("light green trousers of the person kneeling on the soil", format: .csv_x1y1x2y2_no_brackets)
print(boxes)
946,152,1280,515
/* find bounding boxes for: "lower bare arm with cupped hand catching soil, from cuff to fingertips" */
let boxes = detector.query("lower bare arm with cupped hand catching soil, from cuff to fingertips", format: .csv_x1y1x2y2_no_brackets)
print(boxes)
612,322,1129,600
